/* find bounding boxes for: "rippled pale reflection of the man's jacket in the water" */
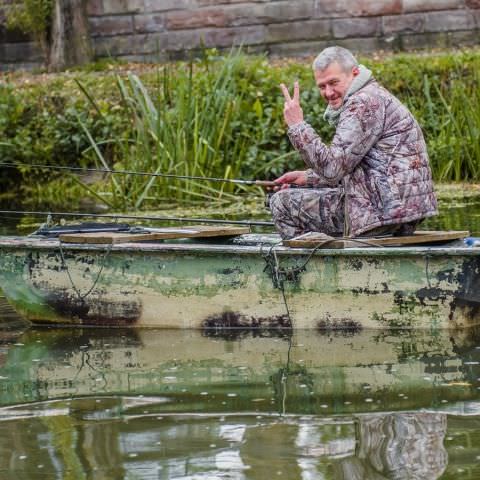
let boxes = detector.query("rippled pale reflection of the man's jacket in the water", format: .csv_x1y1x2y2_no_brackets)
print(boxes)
333,413,448,480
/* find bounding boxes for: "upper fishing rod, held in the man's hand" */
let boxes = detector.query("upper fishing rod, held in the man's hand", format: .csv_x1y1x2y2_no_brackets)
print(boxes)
0,163,278,187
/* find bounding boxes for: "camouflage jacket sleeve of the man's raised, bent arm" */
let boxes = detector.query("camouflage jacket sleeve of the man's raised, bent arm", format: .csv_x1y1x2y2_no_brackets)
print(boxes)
288,94,385,186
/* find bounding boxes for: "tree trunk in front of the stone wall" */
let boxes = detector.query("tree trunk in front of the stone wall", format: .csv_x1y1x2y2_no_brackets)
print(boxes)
48,0,93,71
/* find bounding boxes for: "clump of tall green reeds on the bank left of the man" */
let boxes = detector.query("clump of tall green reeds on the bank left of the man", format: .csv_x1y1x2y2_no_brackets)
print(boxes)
81,51,249,209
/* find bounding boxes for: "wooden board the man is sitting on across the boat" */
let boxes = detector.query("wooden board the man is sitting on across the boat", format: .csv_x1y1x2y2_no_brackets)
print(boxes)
283,230,470,248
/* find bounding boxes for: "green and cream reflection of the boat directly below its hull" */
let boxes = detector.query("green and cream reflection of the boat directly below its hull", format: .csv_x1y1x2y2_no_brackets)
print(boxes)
0,329,480,414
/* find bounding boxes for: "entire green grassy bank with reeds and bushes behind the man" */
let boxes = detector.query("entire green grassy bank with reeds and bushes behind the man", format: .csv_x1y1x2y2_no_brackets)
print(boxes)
0,50,480,210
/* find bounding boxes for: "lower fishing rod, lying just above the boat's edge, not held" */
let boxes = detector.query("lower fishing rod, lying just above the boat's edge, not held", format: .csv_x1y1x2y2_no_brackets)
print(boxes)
0,210,274,227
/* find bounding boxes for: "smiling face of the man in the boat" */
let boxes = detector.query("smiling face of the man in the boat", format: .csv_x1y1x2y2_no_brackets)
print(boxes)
315,62,359,110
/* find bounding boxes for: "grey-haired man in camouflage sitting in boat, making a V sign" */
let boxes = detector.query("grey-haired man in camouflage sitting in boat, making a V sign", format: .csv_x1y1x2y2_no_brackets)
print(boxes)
270,47,438,239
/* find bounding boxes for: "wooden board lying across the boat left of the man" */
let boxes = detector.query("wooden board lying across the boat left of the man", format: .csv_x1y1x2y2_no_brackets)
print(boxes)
59,225,250,244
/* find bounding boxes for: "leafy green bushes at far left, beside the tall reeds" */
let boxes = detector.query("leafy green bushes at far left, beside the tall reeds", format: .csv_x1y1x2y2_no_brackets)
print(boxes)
0,76,127,207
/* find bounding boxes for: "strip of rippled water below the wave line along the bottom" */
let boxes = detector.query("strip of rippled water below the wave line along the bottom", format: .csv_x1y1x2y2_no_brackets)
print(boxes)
0,404,480,480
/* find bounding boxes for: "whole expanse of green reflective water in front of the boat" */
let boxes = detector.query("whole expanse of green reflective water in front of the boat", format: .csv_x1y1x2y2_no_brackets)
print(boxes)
0,328,480,480
